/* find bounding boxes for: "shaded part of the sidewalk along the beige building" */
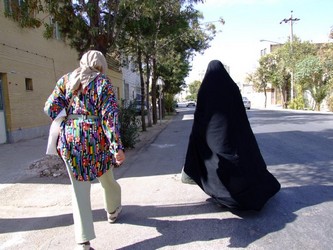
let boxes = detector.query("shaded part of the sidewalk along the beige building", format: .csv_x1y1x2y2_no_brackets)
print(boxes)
0,116,172,184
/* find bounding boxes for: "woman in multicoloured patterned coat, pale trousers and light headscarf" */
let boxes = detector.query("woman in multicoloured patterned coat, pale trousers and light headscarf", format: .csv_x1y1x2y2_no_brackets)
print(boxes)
44,50,125,249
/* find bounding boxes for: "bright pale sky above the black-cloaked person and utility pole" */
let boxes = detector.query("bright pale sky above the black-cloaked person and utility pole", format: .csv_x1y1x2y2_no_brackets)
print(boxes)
186,0,333,84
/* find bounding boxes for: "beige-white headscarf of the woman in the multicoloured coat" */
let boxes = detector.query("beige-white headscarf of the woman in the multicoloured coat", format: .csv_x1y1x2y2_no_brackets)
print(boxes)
66,50,108,93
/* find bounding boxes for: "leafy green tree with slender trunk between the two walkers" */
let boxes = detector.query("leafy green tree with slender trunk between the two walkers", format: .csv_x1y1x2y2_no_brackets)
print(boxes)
120,0,215,124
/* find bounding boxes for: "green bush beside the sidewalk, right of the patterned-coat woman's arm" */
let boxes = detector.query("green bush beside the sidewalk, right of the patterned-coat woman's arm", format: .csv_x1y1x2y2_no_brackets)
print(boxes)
119,100,139,148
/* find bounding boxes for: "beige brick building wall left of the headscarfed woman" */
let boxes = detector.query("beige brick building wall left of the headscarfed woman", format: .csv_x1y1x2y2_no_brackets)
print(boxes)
0,4,123,142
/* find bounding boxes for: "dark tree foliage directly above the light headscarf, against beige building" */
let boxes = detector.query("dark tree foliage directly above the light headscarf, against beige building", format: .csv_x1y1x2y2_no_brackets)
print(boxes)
5,0,137,56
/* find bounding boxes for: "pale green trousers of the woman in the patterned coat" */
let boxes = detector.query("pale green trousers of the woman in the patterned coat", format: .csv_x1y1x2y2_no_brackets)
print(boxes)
67,163,121,243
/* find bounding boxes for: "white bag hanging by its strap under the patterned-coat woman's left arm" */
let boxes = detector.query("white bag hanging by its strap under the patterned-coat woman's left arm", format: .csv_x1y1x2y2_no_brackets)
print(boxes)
46,95,74,155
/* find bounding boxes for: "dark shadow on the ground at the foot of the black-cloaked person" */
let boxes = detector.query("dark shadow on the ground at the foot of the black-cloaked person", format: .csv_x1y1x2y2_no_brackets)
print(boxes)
112,186,333,250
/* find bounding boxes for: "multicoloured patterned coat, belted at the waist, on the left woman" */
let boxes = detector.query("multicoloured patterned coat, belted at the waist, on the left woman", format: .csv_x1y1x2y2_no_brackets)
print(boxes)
44,73,124,181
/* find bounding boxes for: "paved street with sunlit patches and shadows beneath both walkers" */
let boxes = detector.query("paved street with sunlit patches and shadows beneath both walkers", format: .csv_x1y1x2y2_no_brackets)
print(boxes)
0,108,333,250
